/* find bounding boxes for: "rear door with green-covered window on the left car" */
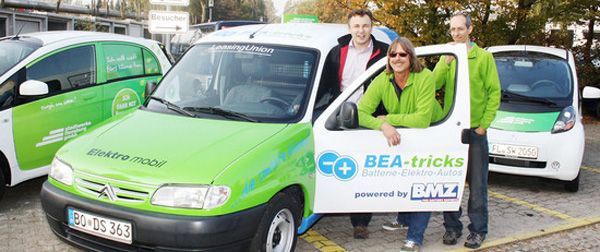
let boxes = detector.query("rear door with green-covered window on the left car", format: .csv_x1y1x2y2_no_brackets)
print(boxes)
98,42,162,118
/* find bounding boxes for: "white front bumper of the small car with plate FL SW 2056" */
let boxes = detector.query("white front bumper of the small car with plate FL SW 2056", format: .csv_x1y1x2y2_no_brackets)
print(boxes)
488,123,585,181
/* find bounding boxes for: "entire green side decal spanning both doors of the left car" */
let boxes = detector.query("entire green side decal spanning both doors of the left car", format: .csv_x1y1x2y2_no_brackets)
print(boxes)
13,42,162,170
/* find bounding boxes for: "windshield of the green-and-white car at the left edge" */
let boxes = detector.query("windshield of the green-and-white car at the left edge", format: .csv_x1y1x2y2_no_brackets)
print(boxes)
0,39,39,76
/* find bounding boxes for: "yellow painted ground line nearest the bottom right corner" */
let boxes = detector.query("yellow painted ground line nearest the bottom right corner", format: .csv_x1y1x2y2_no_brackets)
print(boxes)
450,216,600,252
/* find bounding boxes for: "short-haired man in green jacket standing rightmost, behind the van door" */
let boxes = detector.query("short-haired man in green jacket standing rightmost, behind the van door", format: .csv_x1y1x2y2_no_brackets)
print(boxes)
433,13,500,248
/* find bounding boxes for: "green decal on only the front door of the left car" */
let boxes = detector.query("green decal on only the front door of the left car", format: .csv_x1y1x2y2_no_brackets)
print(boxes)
13,87,103,170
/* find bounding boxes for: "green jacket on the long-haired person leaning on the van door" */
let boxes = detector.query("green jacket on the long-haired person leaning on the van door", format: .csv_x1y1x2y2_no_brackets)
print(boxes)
358,69,435,130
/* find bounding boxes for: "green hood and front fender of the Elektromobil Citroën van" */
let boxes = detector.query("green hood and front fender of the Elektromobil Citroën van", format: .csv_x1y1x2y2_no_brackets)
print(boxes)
50,110,315,216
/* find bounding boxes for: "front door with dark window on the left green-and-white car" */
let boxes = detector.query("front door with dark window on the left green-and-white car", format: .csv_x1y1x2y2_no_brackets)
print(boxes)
13,44,102,170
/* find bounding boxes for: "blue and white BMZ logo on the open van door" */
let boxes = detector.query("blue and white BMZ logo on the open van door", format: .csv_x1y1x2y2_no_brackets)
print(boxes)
410,183,458,202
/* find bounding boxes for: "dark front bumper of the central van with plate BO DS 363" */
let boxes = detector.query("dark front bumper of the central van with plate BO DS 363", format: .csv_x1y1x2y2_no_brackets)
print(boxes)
40,181,266,251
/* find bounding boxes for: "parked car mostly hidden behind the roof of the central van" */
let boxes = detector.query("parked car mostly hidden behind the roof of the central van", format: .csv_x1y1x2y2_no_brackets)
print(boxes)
171,20,265,60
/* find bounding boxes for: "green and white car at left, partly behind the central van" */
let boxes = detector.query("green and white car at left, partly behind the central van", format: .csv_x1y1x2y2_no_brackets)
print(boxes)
0,31,171,198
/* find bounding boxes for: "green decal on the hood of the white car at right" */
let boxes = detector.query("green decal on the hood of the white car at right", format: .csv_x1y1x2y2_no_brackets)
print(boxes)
491,110,560,132
